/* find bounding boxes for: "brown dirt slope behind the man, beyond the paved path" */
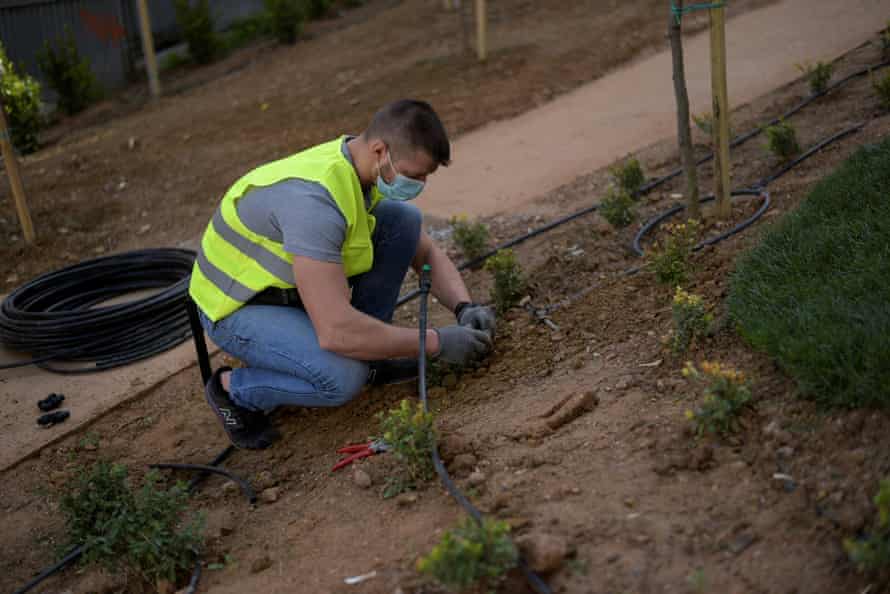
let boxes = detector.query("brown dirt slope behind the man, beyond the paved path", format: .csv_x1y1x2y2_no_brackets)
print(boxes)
0,0,769,292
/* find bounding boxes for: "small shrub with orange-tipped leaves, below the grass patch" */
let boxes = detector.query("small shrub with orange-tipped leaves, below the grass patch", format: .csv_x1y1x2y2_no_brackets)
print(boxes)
683,361,751,437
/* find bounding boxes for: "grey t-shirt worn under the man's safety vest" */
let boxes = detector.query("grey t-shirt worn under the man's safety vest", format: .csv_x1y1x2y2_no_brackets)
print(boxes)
237,137,370,263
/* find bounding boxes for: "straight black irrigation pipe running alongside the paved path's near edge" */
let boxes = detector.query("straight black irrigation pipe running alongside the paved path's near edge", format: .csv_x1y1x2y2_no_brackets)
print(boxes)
396,60,890,307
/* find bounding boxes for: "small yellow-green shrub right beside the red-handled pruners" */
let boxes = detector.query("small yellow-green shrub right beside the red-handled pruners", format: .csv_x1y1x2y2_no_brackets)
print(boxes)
377,400,436,498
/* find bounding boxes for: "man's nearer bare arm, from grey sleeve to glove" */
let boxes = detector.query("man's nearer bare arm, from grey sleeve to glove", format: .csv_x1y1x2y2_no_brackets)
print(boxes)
293,256,440,361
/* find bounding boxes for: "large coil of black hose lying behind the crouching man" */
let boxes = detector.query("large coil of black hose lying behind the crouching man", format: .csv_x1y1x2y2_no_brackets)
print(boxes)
0,248,195,373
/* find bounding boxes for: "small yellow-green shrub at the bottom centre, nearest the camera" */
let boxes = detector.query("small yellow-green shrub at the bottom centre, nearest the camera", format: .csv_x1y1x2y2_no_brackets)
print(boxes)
417,518,519,591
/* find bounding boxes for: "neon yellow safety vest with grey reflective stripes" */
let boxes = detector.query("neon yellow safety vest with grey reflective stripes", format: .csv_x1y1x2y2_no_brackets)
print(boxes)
189,136,382,322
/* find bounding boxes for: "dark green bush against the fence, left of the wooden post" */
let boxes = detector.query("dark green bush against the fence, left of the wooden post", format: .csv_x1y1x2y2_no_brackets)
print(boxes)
37,27,102,115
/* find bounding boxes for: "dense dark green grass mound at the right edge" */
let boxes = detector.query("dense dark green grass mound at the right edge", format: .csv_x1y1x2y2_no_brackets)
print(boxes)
728,139,890,407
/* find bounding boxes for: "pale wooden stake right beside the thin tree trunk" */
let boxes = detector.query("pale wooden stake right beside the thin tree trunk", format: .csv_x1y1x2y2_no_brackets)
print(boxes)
710,6,732,219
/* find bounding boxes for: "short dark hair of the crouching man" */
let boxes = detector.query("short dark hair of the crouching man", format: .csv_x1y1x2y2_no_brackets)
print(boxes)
365,99,451,166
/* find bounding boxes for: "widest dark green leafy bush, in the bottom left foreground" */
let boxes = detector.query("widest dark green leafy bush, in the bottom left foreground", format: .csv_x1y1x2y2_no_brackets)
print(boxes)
60,462,204,583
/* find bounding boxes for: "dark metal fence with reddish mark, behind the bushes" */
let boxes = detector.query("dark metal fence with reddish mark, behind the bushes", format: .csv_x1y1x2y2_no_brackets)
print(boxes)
0,0,263,100
